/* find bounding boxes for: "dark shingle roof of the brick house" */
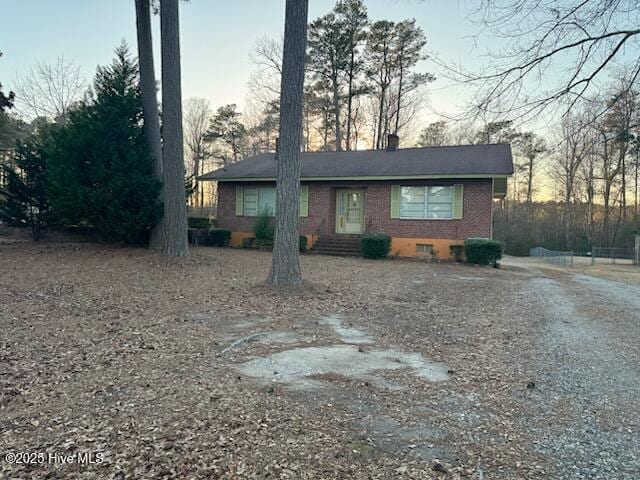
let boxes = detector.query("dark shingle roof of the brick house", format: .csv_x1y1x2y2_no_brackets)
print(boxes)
199,144,513,181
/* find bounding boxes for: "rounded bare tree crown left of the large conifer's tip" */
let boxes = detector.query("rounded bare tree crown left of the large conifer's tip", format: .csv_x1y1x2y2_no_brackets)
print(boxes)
15,56,87,123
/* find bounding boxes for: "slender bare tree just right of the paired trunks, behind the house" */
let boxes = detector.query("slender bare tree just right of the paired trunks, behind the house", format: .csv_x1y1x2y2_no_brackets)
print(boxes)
183,97,212,207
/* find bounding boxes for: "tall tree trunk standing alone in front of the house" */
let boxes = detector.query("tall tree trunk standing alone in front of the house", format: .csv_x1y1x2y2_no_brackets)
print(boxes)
268,0,309,286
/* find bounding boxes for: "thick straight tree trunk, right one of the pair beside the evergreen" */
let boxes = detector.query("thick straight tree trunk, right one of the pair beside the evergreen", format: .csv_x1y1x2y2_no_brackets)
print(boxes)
160,0,189,257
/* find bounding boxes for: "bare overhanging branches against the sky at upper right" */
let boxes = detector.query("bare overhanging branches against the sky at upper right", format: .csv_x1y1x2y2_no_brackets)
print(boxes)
462,0,640,119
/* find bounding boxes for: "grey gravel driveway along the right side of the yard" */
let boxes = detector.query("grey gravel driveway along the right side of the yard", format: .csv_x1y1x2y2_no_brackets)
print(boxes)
508,262,640,480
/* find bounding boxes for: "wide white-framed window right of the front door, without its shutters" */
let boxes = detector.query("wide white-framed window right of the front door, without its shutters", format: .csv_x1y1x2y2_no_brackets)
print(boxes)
400,186,454,219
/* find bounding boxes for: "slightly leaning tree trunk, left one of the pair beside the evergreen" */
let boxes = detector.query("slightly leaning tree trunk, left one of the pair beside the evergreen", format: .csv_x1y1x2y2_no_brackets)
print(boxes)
135,0,164,250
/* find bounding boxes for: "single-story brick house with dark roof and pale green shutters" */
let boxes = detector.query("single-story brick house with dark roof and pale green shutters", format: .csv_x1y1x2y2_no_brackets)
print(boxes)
200,137,513,258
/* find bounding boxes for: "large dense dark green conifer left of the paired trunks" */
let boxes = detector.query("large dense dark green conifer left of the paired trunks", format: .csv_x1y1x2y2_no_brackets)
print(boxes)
47,44,160,243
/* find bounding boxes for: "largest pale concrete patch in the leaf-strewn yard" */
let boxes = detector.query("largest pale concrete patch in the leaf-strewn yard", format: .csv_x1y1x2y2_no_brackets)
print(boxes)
238,345,448,388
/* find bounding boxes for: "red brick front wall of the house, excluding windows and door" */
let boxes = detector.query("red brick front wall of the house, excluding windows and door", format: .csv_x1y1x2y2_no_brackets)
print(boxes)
217,179,492,240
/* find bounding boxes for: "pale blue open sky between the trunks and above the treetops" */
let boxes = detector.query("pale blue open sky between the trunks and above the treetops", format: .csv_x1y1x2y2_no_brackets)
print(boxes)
0,0,499,124
